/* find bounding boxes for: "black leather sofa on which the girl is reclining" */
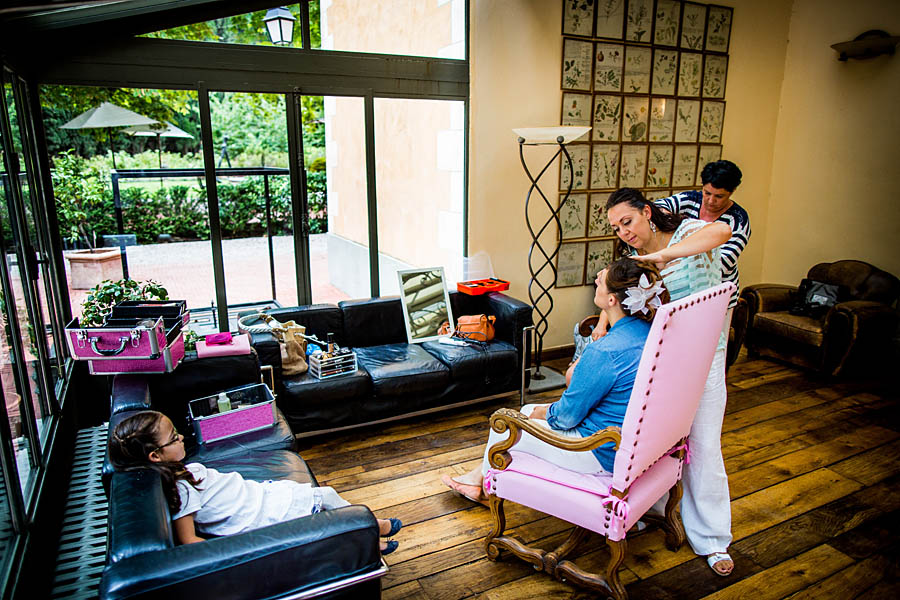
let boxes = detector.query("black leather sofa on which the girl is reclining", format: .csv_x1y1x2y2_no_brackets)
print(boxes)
100,353,387,600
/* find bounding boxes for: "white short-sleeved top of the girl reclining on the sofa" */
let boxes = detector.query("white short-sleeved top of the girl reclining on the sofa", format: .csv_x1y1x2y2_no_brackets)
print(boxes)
172,463,312,535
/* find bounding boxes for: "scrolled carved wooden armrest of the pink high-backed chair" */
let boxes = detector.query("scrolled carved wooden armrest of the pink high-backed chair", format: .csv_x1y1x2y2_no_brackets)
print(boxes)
488,408,622,469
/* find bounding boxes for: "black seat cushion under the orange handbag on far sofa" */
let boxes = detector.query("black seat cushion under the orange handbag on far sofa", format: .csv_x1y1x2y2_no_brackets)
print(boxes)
422,341,519,384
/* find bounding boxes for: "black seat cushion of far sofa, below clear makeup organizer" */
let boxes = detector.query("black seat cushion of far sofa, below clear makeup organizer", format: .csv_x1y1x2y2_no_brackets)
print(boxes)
275,368,372,432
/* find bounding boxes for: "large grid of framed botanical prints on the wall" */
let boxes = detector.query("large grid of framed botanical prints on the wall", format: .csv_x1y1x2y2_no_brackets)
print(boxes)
556,0,733,287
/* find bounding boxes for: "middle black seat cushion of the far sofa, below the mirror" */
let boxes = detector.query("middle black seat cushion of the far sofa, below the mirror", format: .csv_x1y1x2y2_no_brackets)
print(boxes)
356,343,450,398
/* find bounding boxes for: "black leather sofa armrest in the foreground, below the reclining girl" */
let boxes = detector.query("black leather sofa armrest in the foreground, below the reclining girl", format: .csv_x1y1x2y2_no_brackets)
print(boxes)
100,506,383,600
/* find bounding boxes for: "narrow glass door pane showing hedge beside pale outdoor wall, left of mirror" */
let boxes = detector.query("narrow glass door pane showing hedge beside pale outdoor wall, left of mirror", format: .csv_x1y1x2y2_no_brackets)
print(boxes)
303,96,371,304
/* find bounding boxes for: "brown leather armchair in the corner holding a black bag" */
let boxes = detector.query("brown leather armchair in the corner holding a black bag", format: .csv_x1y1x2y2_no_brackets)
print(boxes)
741,260,900,375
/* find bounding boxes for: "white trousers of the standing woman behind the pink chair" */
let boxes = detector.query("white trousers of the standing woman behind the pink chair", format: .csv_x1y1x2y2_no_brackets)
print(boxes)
681,309,732,556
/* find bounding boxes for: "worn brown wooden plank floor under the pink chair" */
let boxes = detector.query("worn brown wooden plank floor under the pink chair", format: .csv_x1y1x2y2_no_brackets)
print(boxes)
301,357,900,600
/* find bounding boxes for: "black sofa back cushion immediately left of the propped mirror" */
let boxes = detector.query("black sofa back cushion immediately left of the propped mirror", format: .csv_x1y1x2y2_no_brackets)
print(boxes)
338,296,407,349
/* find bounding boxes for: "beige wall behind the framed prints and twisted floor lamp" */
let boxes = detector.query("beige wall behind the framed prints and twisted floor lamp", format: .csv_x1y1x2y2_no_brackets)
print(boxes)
468,0,790,347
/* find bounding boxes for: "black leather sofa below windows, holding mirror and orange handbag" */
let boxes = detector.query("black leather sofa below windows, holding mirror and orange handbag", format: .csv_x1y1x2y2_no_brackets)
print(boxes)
244,292,532,437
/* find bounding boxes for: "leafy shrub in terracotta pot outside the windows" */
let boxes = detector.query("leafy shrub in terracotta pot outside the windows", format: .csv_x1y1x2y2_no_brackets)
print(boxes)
51,150,122,290
